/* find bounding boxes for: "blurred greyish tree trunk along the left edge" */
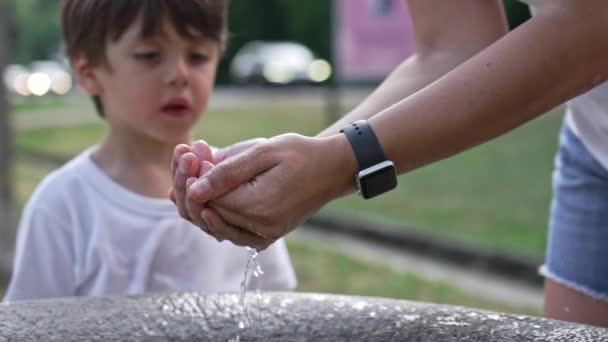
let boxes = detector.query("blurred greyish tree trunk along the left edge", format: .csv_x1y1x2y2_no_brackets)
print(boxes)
0,1,16,282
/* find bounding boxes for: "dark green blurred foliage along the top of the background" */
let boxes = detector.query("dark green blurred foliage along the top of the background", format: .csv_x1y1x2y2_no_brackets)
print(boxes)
9,0,530,82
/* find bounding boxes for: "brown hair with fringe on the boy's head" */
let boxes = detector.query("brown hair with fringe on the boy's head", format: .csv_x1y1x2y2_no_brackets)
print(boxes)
61,0,229,116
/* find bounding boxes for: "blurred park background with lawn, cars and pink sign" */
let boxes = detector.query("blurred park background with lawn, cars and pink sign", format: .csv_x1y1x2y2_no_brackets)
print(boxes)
0,0,562,314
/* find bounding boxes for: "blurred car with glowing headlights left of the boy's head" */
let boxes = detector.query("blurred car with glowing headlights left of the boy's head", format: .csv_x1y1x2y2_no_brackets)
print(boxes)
3,61,73,96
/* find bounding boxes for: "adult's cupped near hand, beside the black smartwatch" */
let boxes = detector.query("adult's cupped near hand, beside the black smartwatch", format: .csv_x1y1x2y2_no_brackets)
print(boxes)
185,134,356,250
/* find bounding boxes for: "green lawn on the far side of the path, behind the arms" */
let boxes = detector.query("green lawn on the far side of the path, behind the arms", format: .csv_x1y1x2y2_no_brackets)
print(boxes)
17,95,561,258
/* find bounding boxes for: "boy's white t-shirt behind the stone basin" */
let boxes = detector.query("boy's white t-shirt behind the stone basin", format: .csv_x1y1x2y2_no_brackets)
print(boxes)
4,148,296,301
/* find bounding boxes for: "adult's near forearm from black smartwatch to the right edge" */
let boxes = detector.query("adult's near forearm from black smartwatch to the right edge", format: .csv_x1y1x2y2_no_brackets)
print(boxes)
369,6,608,172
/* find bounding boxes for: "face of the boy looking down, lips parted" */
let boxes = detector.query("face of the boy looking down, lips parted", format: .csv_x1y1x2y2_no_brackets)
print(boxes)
74,15,220,144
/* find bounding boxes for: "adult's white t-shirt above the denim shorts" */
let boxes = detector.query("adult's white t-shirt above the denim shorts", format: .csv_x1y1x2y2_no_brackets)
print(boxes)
520,0,608,169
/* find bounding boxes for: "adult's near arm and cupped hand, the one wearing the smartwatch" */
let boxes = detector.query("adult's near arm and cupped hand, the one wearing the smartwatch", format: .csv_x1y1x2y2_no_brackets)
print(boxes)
182,0,608,248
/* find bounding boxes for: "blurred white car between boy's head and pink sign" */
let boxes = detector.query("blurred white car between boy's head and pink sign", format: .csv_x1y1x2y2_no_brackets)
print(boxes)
230,41,332,85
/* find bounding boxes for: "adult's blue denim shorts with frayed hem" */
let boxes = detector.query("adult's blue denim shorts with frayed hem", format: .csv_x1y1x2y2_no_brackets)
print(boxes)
540,123,608,302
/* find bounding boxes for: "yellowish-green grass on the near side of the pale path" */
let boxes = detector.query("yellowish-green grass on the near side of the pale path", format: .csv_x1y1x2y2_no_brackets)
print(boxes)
8,162,541,315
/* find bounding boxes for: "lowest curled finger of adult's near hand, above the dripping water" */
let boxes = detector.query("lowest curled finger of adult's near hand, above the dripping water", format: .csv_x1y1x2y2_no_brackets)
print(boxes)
201,208,272,250
